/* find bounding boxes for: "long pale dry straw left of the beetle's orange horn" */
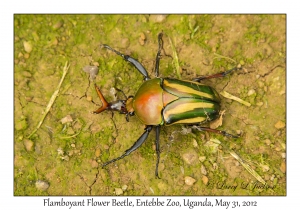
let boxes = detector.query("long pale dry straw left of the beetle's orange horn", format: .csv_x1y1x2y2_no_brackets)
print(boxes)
27,61,70,138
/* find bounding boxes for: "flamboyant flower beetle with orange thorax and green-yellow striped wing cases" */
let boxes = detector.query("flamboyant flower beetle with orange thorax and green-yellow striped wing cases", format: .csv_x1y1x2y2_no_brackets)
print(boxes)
93,33,241,178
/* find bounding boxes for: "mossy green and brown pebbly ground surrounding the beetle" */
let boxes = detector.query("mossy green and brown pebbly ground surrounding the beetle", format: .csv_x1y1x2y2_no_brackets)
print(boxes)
14,15,286,195
